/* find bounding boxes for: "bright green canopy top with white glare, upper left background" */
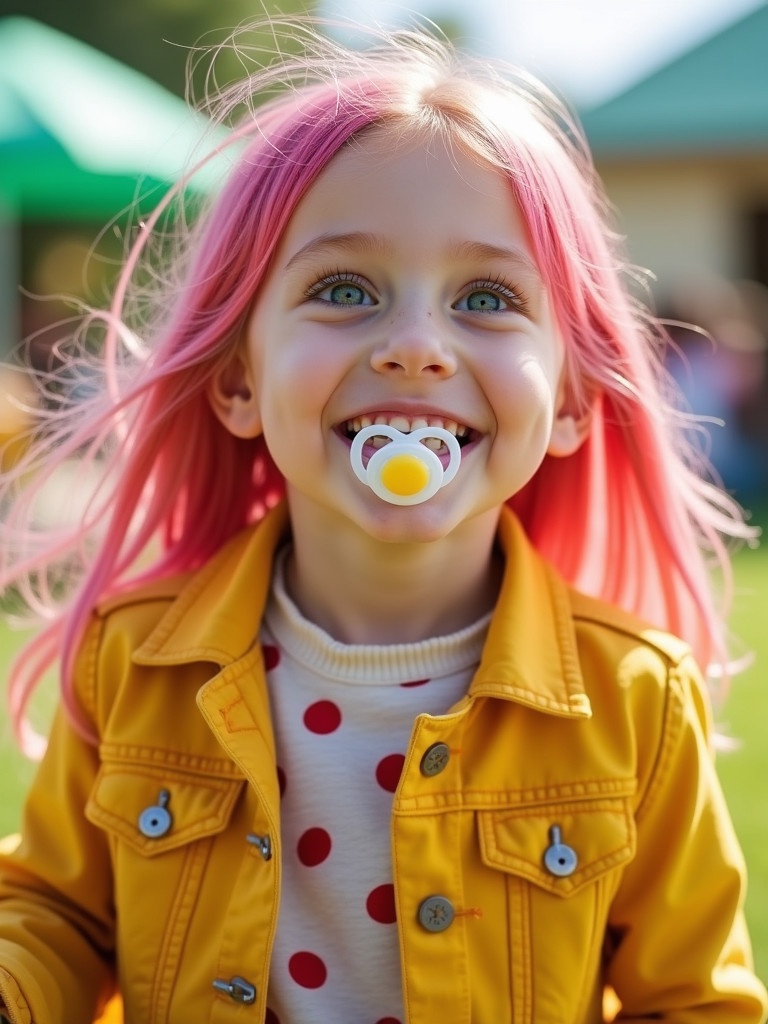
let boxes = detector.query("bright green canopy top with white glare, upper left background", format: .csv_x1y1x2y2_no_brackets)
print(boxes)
0,17,217,220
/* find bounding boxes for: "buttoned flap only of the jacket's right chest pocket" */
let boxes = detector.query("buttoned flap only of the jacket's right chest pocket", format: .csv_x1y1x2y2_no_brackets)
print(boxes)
478,798,635,896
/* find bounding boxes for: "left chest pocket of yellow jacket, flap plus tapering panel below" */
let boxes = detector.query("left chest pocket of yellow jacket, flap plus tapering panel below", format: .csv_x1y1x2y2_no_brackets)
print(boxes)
85,760,245,1024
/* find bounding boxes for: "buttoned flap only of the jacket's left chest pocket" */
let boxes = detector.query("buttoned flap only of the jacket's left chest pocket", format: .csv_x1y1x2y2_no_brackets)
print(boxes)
85,763,245,857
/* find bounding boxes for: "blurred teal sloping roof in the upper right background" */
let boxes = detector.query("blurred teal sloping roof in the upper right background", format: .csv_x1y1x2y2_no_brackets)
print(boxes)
582,3,768,158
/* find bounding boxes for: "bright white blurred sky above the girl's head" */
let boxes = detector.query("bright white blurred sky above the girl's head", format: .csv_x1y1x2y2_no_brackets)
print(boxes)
323,0,765,104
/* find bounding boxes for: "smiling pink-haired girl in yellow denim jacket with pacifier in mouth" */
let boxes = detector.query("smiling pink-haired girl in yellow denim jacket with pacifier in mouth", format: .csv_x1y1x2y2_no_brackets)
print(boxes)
0,18,765,1024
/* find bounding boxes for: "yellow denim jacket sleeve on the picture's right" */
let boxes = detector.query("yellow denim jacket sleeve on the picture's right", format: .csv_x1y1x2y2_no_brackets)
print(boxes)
607,657,766,1024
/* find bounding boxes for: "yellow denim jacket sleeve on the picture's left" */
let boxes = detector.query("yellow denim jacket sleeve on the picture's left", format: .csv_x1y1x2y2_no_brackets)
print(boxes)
0,610,114,1024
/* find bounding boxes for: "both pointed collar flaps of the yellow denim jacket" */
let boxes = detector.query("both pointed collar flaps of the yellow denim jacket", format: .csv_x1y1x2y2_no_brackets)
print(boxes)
134,505,591,718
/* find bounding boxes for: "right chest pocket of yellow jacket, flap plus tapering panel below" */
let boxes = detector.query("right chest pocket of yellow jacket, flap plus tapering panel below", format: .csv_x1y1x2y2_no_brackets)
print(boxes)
478,783,636,1024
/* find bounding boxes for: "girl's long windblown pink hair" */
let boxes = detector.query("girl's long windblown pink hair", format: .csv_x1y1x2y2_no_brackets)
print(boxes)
0,23,750,745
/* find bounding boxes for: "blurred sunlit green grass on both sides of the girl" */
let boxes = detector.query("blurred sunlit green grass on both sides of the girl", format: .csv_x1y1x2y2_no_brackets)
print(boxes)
0,528,768,980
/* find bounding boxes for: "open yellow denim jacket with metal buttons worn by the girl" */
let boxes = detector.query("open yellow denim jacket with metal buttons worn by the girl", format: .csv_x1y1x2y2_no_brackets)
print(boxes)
0,510,765,1024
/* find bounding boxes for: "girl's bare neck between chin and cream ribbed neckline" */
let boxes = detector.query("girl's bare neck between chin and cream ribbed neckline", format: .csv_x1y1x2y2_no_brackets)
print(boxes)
286,497,502,644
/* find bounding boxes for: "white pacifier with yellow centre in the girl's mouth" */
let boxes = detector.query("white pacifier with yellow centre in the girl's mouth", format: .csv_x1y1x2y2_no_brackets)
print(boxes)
349,423,462,505
